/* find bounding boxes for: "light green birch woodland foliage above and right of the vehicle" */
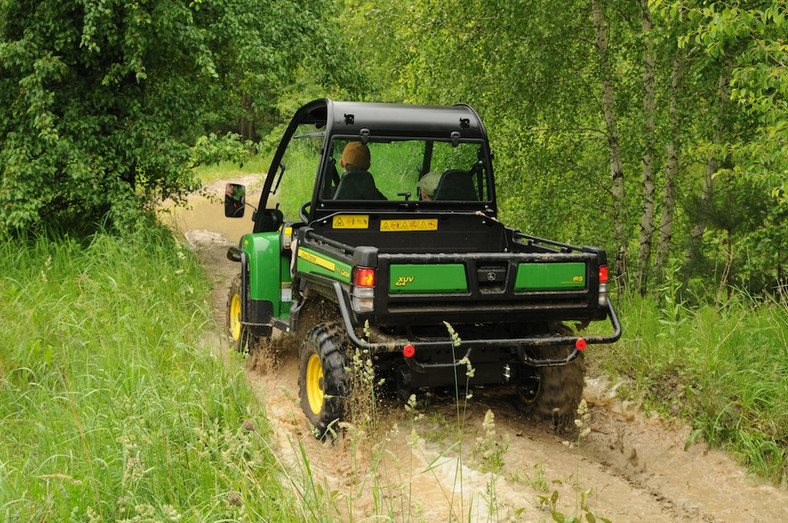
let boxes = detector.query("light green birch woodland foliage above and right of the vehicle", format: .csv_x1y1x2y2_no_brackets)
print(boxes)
344,0,788,292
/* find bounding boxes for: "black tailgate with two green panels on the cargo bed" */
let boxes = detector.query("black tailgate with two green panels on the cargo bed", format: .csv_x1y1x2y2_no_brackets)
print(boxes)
375,252,607,324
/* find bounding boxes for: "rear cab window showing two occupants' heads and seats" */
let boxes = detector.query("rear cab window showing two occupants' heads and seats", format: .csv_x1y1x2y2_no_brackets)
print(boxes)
320,138,490,202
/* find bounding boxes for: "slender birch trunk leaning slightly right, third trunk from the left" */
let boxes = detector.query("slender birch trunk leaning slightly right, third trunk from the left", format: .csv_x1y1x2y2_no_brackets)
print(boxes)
654,50,684,282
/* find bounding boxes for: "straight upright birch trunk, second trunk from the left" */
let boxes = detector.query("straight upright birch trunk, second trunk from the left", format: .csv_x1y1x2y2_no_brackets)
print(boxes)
636,0,656,296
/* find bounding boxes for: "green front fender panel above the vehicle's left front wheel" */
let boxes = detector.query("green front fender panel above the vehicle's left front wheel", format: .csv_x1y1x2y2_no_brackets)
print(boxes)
241,231,290,317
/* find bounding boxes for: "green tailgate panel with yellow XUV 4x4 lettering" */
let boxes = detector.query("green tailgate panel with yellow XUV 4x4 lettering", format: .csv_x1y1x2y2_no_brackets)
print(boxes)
389,263,468,294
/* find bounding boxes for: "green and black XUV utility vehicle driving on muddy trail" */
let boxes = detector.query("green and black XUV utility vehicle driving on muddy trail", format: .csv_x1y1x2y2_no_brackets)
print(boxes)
225,99,621,436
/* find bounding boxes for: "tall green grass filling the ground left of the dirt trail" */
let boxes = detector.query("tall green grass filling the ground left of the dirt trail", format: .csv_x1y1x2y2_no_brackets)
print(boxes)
0,229,304,521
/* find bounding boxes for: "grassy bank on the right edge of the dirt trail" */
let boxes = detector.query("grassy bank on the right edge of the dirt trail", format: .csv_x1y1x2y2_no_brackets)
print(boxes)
599,289,788,485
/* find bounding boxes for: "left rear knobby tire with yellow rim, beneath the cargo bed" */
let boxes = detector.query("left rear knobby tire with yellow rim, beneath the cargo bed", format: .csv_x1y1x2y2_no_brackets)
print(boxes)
298,324,352,438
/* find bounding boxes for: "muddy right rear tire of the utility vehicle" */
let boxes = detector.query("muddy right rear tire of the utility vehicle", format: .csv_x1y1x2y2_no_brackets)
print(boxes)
516,347,586,428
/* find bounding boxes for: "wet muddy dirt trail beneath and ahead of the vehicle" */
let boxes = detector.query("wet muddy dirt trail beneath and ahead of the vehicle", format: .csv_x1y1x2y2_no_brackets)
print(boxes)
171,184,788,522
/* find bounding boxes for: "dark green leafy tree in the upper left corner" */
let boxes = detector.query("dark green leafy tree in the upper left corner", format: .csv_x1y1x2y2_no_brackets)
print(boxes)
0,0,338,230
